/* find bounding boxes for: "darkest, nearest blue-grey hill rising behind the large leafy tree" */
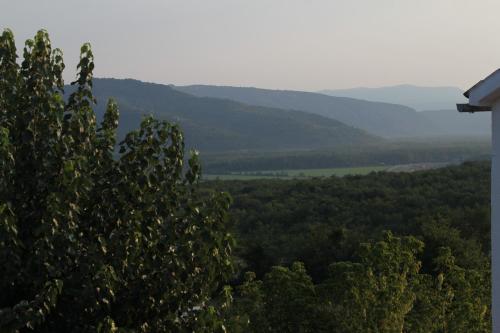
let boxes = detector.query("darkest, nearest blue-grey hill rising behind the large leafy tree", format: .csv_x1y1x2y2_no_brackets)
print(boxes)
82,79,381,152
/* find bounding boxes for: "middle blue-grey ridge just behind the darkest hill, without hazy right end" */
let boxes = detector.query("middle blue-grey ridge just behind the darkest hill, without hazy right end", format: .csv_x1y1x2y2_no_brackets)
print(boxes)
175,85,440,138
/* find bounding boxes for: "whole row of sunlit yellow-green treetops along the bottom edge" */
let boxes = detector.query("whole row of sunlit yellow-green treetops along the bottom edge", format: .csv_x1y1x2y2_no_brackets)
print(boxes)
228,232,491,333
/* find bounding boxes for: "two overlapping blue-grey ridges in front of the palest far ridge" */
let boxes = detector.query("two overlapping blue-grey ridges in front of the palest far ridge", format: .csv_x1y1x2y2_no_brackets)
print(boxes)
79,79,490,152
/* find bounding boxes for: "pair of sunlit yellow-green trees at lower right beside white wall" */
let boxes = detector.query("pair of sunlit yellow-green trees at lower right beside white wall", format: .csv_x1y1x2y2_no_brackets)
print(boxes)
318,232,491,333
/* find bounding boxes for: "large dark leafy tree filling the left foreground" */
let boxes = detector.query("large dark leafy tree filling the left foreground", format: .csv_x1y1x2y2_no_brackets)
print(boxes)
0,30,232,332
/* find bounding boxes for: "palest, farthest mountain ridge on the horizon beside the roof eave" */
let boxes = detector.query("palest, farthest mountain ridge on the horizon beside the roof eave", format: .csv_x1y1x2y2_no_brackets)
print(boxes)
320,84,465,111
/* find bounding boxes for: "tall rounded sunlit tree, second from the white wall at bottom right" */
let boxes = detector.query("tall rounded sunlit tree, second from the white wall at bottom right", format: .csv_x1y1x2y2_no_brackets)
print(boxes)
322,233,423,332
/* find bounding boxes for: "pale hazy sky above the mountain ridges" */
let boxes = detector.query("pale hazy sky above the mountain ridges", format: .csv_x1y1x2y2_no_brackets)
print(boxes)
0,0,500,91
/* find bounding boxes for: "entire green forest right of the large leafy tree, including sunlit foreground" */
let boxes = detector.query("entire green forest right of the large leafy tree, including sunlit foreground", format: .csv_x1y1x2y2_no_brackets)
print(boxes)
205,162,490,332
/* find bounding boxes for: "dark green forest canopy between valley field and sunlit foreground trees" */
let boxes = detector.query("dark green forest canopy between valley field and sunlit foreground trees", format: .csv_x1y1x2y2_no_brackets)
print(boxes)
208,163,490,281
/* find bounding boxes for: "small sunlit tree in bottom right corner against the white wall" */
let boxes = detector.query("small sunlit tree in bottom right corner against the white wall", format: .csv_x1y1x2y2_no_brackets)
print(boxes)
405,247,491,333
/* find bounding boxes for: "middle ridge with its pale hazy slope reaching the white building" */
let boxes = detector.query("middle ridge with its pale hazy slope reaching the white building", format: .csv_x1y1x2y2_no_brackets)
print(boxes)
174,85,490,138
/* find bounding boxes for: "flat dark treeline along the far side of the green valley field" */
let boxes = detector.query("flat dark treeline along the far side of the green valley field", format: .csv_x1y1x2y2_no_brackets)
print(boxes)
202,140,491,174
